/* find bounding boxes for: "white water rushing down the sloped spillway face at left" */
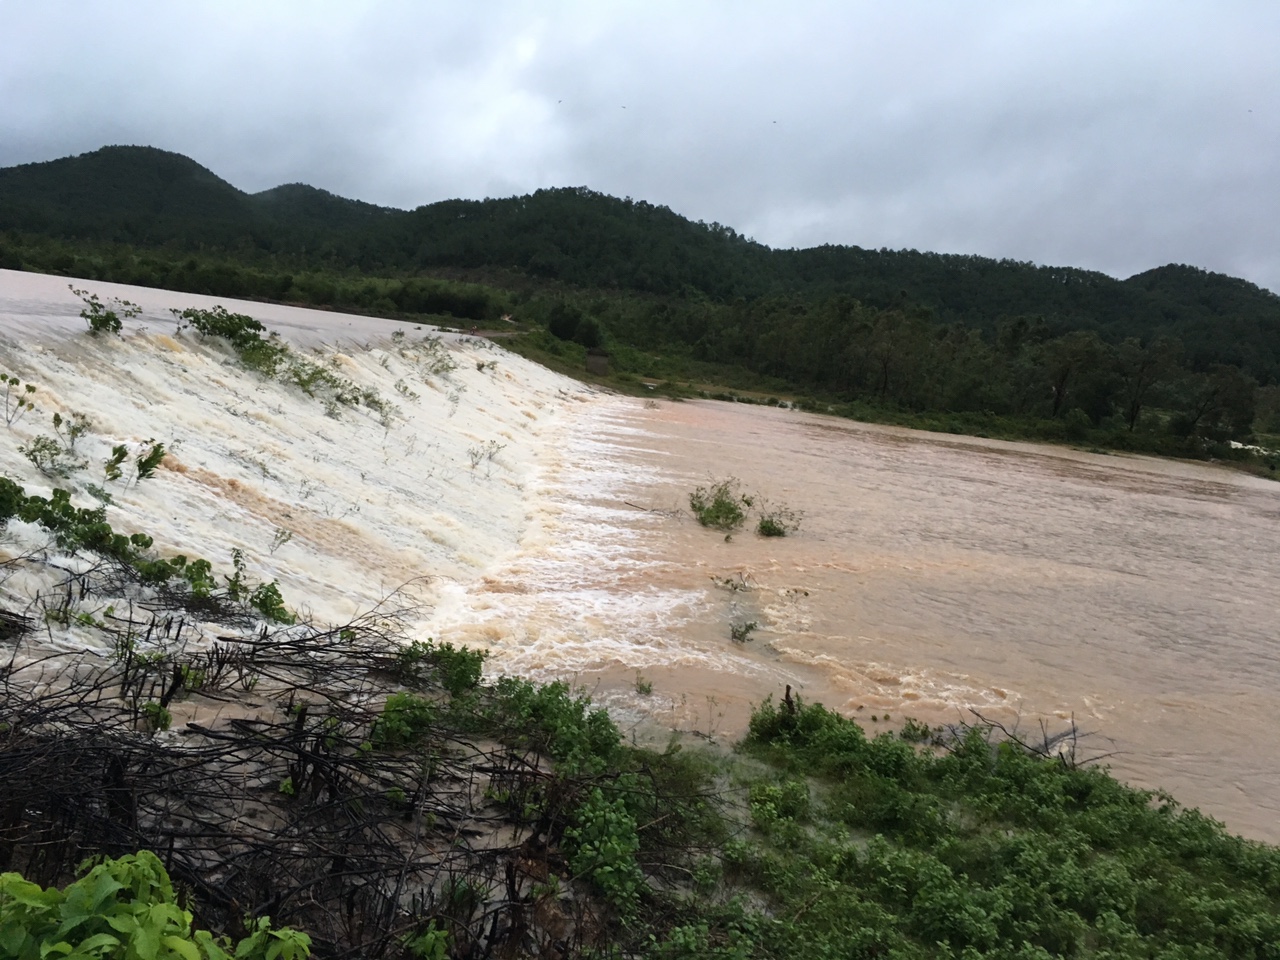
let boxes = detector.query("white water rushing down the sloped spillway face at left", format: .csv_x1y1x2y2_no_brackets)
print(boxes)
0,271,599,649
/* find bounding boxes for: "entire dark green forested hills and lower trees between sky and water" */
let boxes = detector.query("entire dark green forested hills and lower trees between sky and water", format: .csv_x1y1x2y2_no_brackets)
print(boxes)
0,147,1280,451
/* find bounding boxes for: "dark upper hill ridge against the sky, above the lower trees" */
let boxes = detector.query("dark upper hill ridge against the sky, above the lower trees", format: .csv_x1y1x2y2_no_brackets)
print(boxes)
0,147,1280,383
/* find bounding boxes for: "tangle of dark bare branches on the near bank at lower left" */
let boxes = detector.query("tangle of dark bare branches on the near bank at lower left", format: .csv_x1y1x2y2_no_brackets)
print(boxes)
0,608,634,957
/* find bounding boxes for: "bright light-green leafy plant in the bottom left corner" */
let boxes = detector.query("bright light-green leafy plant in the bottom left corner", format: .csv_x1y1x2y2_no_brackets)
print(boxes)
0,850,311,960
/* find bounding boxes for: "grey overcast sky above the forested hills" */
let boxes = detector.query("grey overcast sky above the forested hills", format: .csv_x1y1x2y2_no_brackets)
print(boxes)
0,0,1280,291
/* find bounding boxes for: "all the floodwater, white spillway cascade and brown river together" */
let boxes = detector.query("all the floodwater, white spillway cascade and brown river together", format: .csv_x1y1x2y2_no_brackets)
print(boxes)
0,271,1280,841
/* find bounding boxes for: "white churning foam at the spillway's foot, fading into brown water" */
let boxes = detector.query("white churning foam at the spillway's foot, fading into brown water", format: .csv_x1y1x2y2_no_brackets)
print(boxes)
431,398,760,680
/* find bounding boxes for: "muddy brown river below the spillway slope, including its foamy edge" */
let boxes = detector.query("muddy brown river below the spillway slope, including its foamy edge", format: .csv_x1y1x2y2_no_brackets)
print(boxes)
455,399,1280,842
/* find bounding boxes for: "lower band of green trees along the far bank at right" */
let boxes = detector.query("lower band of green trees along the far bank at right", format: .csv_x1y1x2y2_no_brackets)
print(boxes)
526,296,1280,452
